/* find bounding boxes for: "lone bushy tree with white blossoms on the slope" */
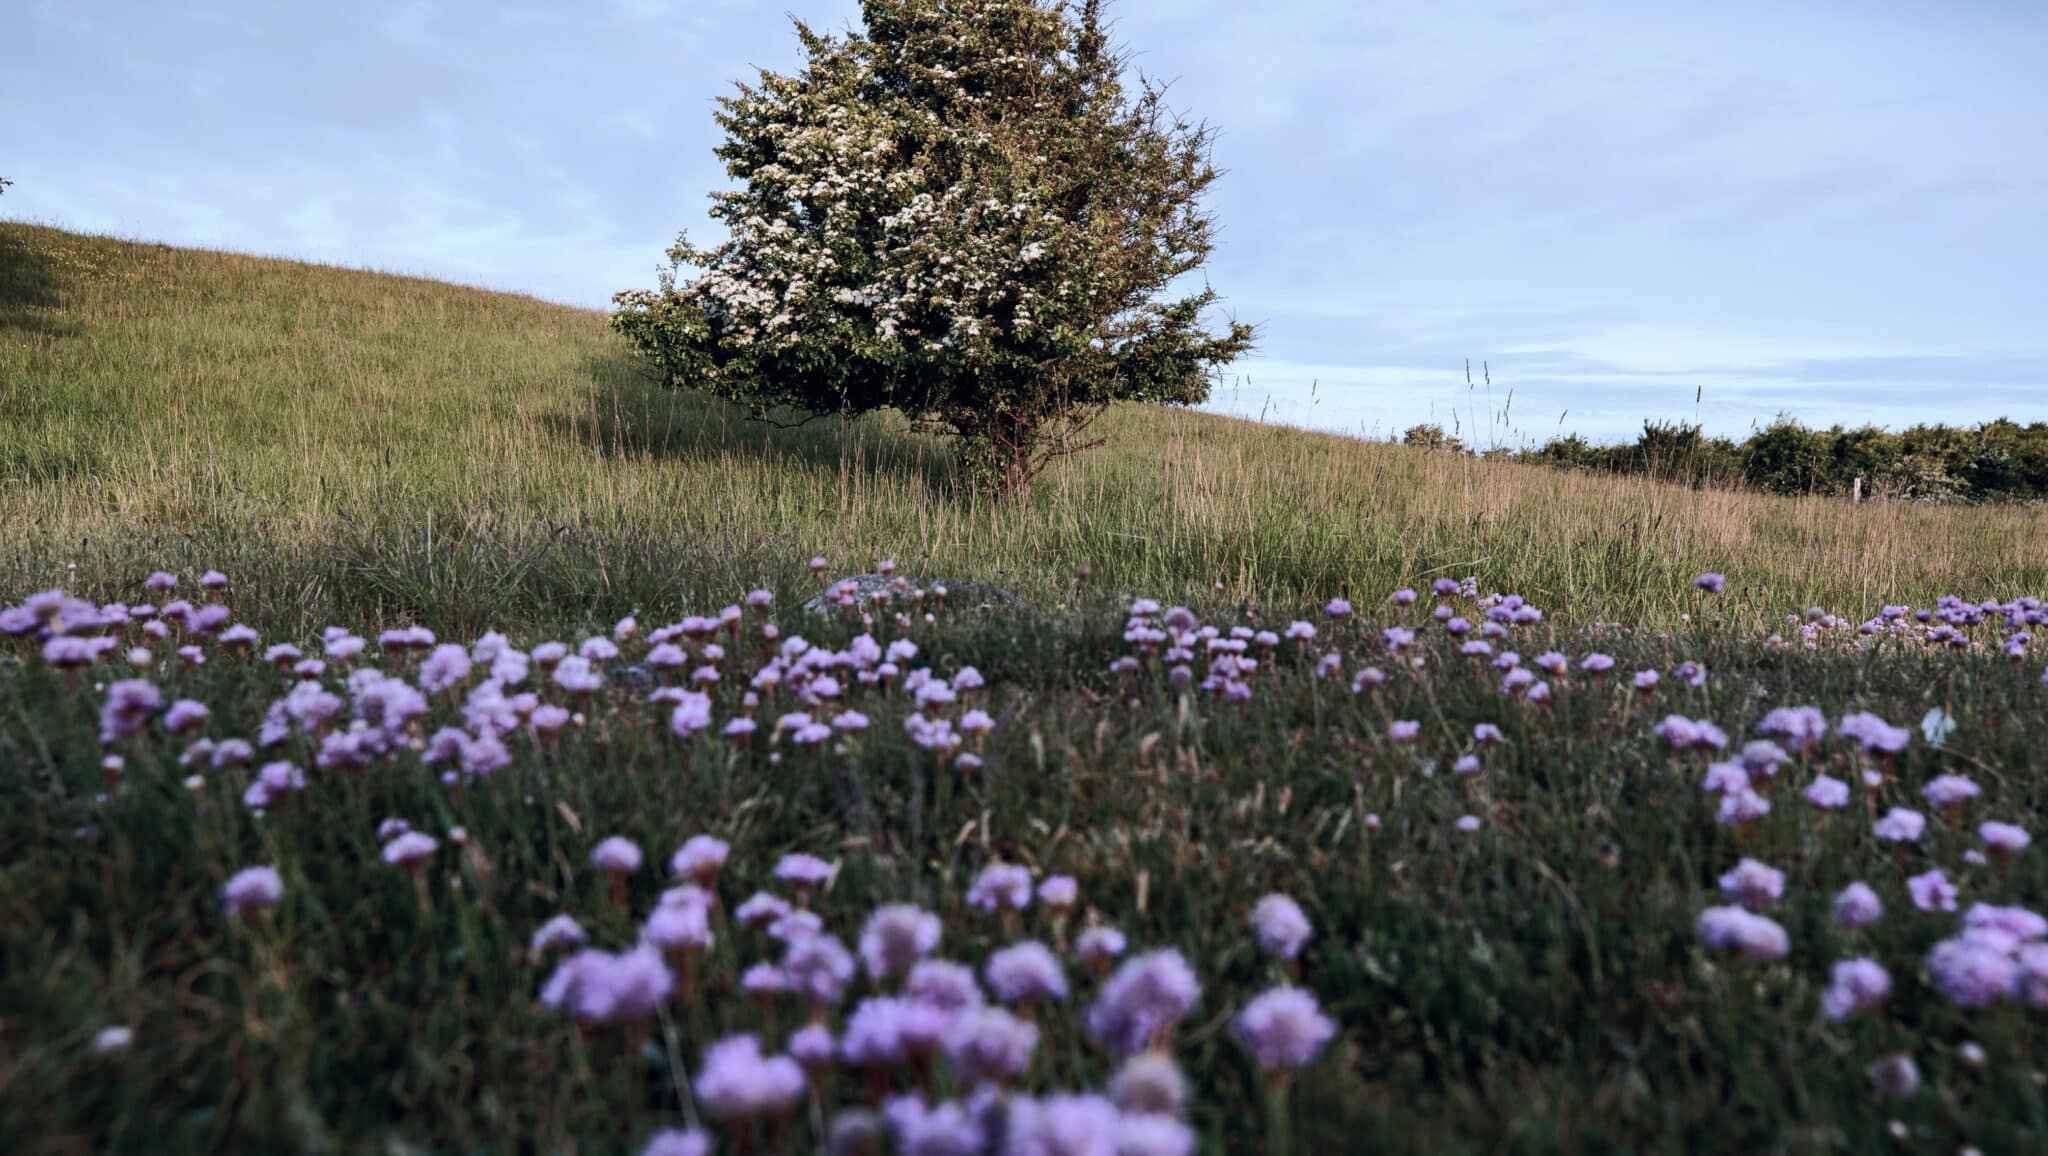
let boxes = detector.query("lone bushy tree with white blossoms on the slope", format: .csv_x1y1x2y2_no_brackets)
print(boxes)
612,0,1253,498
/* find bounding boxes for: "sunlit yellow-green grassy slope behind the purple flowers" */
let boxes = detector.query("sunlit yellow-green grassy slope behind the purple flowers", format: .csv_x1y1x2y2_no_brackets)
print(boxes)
0,223,2048,629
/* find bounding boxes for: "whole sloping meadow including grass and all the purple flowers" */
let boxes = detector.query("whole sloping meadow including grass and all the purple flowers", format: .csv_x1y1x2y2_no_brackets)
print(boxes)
0,225,2048,1156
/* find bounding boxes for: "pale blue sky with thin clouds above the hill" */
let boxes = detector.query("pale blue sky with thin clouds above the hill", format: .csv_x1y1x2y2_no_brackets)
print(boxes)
0,0,2048,443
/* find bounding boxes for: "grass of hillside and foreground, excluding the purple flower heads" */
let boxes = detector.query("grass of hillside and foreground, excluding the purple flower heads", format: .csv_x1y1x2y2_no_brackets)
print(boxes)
0,225,2048,1156
